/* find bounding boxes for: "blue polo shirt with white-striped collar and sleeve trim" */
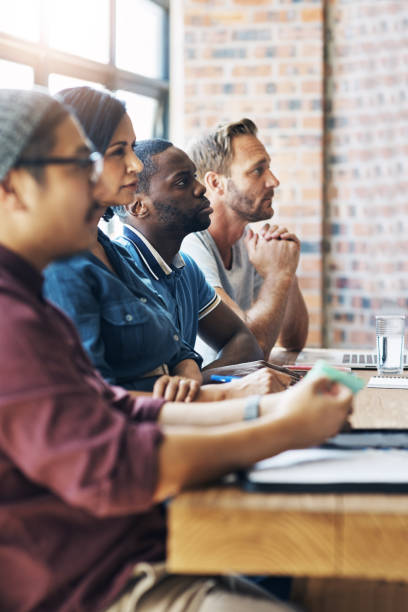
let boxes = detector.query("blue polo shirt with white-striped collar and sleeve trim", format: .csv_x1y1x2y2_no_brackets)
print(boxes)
117,225,221,346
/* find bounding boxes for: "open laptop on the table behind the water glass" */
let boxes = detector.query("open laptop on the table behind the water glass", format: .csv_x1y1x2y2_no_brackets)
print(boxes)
295,349,408,370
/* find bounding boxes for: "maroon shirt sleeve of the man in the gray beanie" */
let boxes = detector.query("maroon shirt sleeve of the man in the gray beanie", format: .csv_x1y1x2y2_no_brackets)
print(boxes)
0,301,164,517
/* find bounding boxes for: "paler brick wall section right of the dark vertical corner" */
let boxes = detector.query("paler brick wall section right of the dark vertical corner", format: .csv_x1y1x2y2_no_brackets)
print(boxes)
325,0,408,346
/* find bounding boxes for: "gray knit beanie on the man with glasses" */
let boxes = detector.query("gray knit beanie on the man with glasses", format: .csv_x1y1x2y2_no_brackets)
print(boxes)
0,89,55,181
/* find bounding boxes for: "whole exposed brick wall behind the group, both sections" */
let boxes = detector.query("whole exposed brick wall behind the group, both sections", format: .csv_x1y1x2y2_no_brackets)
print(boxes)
171,0,408,346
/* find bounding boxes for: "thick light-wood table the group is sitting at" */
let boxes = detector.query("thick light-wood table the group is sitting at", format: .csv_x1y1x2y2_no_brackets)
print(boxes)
168,352,408,612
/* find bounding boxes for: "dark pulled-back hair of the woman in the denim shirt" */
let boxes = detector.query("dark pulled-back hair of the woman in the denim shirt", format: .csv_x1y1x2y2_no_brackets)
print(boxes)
57,87,126,221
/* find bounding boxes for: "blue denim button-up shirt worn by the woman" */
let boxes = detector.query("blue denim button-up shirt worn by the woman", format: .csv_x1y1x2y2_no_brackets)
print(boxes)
44,230,202,390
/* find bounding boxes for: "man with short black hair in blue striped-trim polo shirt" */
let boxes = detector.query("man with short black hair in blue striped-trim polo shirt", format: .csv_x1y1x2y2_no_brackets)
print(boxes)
115,139,274,372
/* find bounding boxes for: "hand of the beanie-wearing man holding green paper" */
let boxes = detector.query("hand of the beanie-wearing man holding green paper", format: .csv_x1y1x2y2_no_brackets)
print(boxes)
261,377,353,448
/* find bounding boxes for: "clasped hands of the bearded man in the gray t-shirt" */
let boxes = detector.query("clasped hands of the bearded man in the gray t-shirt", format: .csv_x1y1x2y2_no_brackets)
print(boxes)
245,228,300,280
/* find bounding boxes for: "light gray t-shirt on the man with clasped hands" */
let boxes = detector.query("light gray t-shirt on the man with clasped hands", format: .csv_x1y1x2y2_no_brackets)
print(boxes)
181,230,263,365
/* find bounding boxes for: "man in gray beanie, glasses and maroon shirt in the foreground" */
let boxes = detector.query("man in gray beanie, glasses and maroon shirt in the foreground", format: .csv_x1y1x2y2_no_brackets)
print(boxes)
0,90,351,612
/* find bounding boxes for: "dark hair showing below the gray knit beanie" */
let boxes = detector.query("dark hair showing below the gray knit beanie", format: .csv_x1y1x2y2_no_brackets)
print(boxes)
16,101,69,183
